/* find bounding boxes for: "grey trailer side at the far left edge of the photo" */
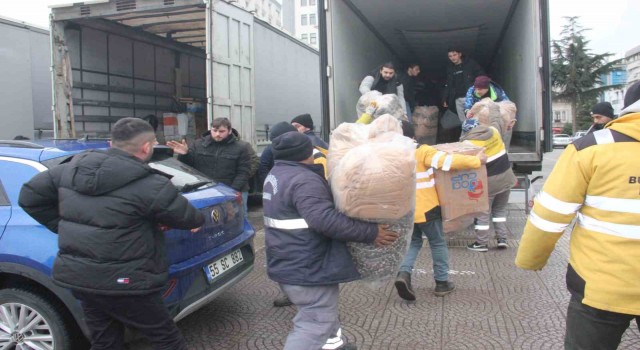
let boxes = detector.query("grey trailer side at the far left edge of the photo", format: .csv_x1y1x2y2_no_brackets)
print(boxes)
0,18,53,139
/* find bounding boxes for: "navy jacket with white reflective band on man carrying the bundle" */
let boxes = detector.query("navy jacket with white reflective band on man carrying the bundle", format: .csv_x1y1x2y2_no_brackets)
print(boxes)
262,160,378,286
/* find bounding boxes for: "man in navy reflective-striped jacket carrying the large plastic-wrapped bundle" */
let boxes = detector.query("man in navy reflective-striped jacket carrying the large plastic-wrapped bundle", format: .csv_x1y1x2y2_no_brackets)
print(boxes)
262,132,398,350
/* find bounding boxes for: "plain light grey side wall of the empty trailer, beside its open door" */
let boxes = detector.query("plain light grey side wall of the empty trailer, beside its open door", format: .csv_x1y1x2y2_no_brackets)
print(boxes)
253,20,322,142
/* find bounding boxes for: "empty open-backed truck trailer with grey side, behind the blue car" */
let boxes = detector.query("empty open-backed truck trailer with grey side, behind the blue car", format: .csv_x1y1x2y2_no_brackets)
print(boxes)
51,0,321,147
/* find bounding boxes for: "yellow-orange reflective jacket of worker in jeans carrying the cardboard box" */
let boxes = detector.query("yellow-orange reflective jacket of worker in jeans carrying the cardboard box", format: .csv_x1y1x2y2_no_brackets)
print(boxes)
414,145,481,224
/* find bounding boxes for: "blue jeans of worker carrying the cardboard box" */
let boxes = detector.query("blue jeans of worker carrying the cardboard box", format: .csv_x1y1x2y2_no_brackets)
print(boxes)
400,219,449,281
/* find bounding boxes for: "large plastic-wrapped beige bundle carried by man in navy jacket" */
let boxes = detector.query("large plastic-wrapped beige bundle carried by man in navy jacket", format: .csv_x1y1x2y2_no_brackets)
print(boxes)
327,115,416,281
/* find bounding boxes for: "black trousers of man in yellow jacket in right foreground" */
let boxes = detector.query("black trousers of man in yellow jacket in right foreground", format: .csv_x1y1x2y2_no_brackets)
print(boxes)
564,297,640,350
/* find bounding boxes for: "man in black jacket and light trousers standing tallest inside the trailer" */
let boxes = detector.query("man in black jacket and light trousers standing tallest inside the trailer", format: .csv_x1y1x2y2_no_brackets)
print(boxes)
443,48,485,123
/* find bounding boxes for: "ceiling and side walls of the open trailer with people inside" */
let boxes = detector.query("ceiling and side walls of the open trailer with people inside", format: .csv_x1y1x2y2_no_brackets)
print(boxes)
329,0,542,160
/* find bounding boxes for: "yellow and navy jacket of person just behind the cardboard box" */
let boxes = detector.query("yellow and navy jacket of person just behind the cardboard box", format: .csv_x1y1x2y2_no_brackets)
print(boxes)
460,125,517,196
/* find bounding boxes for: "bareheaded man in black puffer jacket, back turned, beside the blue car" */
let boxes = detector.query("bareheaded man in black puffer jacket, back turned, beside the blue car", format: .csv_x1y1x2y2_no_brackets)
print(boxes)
19,118,204,350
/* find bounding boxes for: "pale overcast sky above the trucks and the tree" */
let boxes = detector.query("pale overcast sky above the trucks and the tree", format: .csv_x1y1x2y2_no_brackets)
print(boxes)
0,0,640,55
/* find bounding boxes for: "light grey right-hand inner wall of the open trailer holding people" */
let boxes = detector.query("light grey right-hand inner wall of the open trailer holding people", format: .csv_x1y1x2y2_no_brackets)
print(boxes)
491,1,543,160
